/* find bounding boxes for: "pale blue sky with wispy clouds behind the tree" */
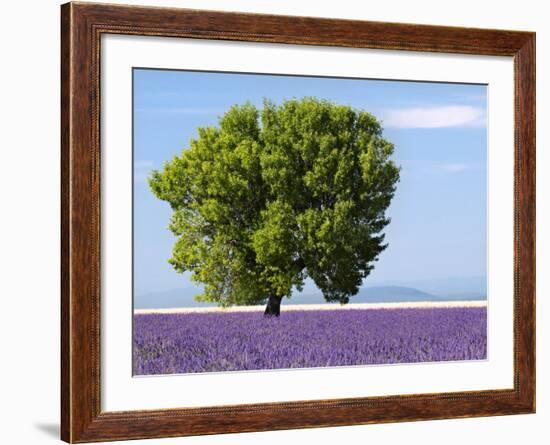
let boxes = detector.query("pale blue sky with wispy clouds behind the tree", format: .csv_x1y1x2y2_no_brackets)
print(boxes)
134,69,487,295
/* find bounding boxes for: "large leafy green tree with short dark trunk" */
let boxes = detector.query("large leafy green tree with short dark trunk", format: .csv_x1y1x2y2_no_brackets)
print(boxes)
149,98,399,316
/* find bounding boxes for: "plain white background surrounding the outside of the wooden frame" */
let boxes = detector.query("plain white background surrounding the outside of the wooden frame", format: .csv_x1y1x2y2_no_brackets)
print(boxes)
0,0,550,445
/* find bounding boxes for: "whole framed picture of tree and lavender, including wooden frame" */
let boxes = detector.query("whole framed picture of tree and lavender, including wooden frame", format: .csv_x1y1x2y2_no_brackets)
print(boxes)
61,3,535,443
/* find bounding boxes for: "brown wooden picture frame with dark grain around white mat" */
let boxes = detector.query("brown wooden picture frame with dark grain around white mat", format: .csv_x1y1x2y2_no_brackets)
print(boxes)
61,3,535,443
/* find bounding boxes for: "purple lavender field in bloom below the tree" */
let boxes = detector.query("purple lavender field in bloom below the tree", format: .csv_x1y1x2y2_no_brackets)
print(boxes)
133,307,487,375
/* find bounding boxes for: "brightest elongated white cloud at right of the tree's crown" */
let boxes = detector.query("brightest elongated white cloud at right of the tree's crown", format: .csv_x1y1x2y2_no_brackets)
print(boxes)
383,105,486,128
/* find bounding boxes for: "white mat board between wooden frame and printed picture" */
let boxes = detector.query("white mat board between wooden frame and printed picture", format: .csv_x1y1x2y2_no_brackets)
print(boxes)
101,35,513,411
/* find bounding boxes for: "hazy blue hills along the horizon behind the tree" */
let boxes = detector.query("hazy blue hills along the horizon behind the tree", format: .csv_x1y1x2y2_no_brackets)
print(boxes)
134,285,485,309
